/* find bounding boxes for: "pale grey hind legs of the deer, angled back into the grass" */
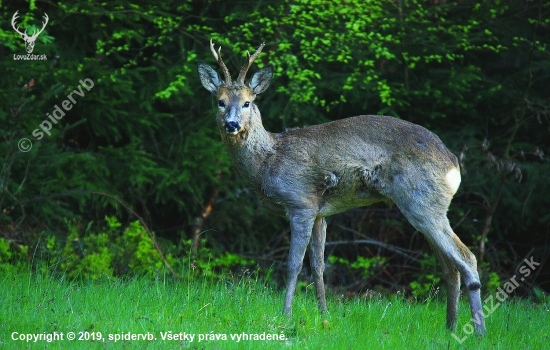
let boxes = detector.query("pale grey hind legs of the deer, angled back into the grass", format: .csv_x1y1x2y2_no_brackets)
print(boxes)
395,196,485,334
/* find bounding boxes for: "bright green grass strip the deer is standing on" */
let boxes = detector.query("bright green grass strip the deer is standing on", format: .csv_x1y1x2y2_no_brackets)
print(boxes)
0,266,550,349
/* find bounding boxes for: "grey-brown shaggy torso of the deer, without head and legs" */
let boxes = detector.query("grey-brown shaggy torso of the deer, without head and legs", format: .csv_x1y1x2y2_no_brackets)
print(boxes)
253,116,458,217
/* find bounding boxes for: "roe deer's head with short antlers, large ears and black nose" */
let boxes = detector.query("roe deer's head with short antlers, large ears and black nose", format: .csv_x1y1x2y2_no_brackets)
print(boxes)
198,40,273,138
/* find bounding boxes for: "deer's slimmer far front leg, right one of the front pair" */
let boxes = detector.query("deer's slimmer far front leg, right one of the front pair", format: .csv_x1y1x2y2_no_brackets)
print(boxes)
309,217,327,313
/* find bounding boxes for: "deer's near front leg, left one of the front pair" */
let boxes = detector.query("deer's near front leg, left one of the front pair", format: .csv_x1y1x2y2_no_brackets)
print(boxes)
283,209,316,315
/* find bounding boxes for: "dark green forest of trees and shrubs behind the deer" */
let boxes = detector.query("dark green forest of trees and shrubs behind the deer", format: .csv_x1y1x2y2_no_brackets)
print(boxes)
0,0,550,300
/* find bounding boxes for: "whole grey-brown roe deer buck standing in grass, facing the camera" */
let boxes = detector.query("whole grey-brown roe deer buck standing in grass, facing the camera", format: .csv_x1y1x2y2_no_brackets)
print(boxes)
198,41,485,334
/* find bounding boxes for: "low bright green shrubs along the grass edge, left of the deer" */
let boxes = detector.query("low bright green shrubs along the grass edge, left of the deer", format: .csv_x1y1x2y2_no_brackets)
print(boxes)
29,216,255,280
